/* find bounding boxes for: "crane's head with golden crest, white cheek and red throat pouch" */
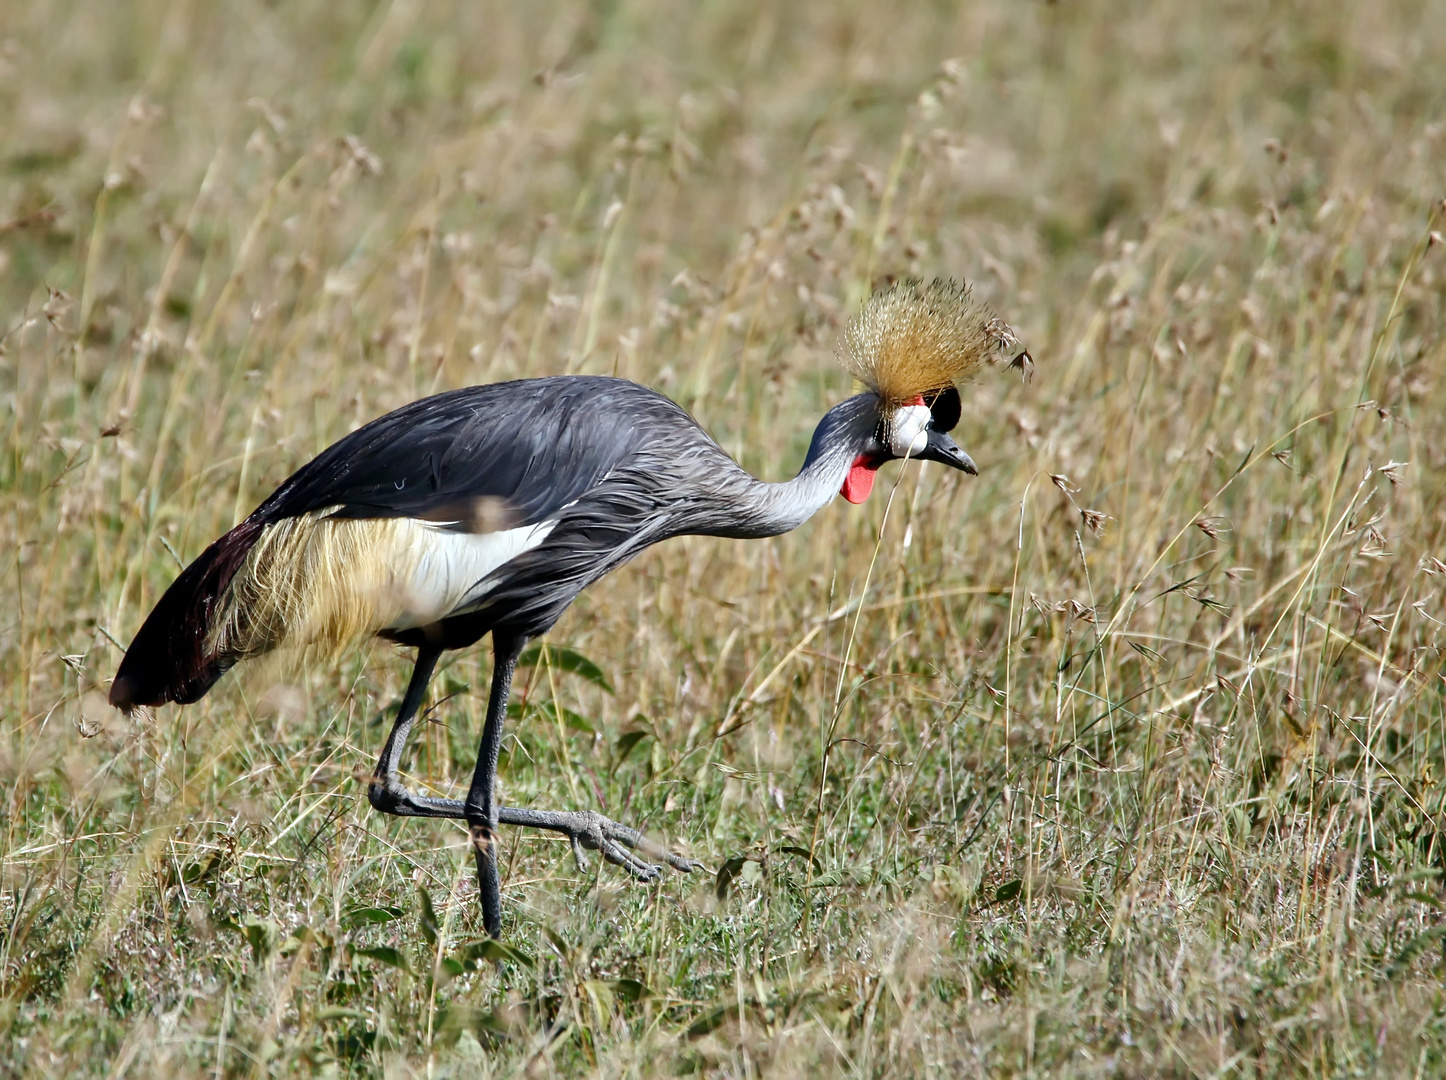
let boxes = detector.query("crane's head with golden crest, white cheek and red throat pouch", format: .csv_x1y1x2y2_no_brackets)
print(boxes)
839,279,1034,503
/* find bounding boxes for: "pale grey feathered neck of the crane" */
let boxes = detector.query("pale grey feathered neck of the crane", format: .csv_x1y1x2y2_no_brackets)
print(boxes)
698,393,879,539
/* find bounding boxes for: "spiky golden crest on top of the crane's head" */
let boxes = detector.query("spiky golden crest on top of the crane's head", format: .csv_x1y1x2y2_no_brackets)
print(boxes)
839,278,1034,409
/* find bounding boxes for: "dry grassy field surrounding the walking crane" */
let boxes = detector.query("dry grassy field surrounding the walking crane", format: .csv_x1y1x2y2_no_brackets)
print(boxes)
0,0,1446,1079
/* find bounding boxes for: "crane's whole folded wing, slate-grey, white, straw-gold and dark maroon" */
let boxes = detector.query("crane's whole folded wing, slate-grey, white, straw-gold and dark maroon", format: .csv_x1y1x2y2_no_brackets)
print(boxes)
111,376,694,708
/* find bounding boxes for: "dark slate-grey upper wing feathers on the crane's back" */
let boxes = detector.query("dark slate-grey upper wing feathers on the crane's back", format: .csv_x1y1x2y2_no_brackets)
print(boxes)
253,377,665,532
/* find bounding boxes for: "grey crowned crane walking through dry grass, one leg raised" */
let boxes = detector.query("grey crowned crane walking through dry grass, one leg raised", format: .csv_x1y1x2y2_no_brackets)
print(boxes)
110,282,1030,937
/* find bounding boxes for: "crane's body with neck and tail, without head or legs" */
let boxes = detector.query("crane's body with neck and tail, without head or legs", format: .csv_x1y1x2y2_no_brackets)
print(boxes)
111,376,876,706
